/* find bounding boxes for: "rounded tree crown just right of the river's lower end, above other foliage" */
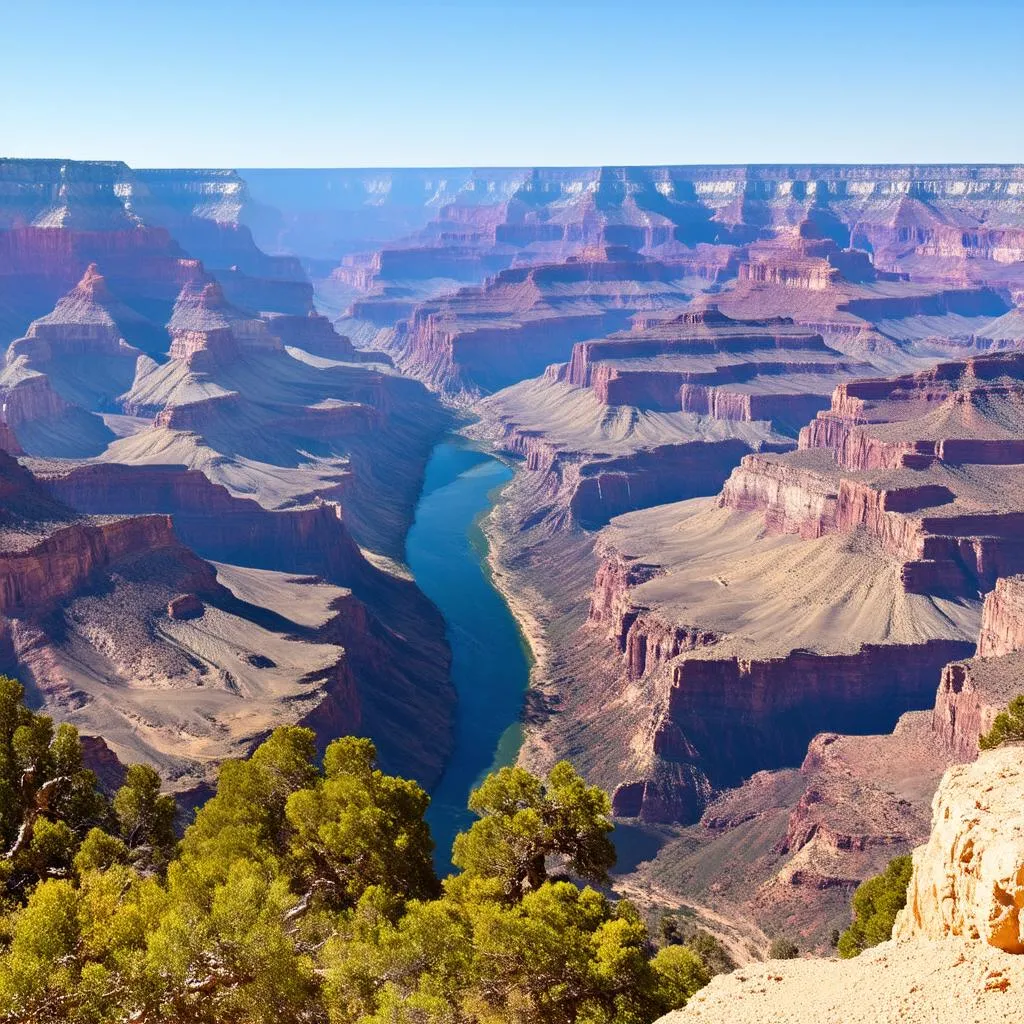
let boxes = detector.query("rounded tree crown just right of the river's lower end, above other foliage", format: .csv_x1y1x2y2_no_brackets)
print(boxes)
452,761,615,900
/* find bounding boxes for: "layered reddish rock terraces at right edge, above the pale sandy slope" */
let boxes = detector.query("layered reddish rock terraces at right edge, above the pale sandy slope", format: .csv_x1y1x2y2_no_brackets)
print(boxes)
721,354,1024,596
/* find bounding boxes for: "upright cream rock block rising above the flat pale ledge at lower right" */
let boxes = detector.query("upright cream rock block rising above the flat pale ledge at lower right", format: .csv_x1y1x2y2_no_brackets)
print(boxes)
893,746,1024,953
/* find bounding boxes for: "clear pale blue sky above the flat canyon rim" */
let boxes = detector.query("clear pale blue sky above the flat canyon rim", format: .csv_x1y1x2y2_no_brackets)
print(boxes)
0,0,1024,167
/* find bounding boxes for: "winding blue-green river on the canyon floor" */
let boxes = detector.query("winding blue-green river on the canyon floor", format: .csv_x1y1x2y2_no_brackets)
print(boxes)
406,440,529,871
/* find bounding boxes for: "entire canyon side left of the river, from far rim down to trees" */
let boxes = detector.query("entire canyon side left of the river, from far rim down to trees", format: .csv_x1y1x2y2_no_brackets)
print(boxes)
0,161,452,791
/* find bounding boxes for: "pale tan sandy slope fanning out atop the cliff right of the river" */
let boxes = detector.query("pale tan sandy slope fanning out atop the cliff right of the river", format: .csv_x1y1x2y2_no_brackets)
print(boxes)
602,499,981,658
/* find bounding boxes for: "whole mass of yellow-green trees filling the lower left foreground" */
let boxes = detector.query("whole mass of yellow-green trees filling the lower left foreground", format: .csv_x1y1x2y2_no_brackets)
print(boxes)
0,680,712,1024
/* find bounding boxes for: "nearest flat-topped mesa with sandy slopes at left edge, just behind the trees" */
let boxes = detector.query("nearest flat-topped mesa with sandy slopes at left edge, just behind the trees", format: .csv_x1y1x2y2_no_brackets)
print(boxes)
0,448,360,790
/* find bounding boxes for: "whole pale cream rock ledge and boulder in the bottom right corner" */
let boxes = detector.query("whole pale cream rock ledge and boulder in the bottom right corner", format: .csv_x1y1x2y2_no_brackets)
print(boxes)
663,746,1024,1024
